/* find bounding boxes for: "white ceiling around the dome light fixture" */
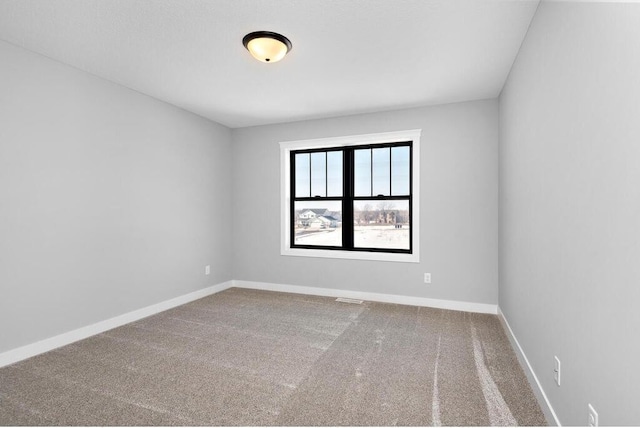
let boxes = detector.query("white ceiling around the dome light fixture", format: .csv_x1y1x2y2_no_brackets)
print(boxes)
0,0,538,128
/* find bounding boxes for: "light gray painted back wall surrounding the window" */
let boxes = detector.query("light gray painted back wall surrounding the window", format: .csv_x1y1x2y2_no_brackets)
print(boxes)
232,100,498,304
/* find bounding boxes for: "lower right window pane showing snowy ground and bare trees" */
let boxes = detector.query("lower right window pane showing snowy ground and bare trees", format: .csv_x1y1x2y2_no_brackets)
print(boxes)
353,200,411,250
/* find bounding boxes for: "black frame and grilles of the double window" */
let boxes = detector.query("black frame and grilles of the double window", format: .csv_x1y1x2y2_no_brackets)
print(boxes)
288,140,414,254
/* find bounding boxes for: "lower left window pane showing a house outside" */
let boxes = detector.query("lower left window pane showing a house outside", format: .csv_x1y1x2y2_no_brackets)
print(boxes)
294,201,342,247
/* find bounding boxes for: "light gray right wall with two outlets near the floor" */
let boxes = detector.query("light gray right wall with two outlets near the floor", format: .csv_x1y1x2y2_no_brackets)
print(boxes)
499,1,640,425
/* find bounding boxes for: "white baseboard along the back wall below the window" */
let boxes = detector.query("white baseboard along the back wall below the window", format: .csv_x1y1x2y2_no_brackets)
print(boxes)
232,280,498,315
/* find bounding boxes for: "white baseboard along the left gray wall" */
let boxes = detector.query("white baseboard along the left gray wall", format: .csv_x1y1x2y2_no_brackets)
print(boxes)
0,281,233,367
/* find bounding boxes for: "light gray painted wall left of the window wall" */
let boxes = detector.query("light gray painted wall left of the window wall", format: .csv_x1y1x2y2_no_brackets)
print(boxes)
0,42,232,352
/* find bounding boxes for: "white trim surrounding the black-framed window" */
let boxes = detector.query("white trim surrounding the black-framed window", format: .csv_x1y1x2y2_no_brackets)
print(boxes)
280,129,422,263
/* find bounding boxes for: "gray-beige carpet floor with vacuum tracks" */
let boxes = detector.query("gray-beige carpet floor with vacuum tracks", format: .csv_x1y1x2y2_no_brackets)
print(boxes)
0,288,546,426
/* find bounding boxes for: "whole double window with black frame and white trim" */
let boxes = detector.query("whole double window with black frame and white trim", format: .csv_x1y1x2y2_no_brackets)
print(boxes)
281,131,420,262
